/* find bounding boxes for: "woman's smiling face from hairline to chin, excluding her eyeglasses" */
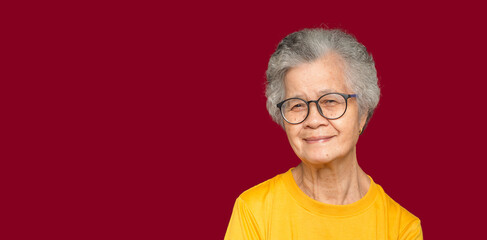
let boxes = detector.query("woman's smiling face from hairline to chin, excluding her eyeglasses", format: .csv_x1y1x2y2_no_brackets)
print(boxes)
284,54,366,167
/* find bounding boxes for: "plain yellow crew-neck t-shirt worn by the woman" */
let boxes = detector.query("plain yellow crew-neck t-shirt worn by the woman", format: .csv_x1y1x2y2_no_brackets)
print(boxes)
225,170,423,240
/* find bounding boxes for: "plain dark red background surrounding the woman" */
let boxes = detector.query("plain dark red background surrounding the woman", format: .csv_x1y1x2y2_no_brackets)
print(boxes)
0,1,487,239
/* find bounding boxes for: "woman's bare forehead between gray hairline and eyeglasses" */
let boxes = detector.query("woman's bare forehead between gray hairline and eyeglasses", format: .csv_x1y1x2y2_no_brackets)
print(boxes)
284,54,349,98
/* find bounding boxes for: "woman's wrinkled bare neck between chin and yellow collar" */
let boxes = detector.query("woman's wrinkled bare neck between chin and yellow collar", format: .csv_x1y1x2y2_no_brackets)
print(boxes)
292,154,370,205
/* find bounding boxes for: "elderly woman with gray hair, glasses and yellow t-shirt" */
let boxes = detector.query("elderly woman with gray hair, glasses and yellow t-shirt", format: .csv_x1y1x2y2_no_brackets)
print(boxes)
225,29,423,240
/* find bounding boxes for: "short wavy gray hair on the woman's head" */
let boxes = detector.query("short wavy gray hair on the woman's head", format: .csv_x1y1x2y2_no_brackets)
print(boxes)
266,28,380,131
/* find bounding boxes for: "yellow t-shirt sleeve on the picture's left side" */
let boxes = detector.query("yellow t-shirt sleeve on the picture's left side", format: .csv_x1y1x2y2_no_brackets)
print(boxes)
225,197,262,240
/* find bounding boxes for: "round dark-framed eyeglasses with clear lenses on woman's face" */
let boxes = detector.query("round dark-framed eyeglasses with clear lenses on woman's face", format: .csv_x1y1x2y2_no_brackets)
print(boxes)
277,93,357,124
